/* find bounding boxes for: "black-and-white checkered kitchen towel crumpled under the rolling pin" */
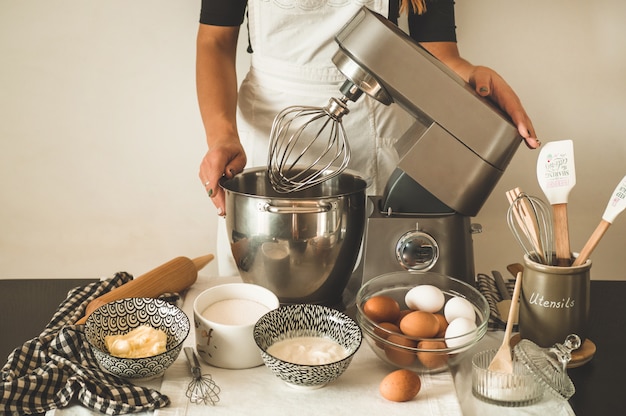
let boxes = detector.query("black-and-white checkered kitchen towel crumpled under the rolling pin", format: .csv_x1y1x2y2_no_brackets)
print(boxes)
0,272,169,415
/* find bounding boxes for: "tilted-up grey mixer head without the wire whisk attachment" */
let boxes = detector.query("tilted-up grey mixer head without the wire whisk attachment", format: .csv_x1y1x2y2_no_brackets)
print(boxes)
333,7,522,216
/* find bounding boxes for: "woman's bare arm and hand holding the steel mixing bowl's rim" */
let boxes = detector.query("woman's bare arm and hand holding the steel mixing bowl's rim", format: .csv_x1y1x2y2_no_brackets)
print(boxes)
196,24,246,215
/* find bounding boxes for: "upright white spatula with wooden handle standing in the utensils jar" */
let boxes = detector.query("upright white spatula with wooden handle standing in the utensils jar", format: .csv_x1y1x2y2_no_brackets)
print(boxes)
537,140,576,266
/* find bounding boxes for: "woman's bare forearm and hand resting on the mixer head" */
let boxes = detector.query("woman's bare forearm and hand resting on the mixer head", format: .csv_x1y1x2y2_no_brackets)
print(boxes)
421,42,541,149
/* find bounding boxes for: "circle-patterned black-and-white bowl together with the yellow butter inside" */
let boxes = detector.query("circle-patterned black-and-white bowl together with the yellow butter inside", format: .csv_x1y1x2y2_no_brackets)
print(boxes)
85,298,191,379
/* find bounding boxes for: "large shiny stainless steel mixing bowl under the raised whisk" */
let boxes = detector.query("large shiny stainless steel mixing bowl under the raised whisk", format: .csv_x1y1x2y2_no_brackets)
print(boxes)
221,167,367,305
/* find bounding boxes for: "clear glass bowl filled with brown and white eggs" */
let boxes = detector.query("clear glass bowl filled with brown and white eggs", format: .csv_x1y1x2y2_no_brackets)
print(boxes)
356,271,489,374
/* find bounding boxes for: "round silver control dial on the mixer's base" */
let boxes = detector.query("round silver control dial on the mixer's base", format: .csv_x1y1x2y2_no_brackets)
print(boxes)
396,230,439,271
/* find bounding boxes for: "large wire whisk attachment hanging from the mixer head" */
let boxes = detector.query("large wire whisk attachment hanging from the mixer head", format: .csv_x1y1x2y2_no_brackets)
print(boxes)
267,81,362,193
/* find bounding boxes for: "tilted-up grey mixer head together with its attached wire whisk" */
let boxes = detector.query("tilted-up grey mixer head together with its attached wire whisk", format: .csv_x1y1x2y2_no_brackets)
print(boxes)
268,7,522,210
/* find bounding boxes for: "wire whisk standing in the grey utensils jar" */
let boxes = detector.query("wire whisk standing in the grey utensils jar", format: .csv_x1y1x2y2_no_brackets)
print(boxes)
506,188,554,265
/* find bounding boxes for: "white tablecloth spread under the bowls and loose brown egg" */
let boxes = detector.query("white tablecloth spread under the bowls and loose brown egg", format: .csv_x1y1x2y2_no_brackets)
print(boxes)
48,278,574,416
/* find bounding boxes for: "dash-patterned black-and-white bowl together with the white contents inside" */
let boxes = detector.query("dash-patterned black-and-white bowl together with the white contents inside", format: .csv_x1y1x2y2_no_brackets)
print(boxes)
254,304,363,389
